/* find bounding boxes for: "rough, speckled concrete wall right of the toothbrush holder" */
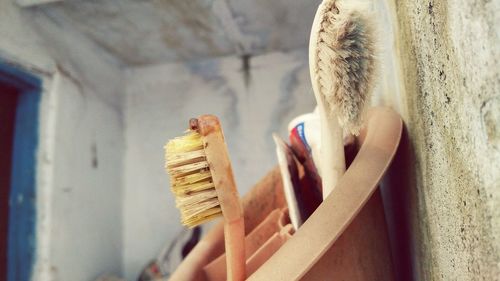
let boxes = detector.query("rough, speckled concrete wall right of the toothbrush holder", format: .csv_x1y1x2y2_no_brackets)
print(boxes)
392,0,500,280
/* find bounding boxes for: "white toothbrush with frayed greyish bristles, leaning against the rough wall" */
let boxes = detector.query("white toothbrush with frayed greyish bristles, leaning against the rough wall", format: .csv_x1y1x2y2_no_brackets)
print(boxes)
309,0,375,199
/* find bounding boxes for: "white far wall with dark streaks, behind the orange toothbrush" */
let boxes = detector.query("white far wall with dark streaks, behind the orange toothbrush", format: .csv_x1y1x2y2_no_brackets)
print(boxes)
123,50,315,280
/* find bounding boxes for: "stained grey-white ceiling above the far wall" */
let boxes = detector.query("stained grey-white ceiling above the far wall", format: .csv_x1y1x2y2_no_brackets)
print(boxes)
26,0,320,66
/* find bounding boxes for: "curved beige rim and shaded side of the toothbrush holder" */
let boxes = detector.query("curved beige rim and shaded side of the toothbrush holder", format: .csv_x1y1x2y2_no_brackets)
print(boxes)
248,108,403,280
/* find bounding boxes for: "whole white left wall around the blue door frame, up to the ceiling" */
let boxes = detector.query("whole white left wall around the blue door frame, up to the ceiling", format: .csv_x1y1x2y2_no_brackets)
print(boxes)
0,0,124,281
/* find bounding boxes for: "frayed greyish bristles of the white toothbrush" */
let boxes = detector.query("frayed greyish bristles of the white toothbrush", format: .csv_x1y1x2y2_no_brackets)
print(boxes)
314,1,376,135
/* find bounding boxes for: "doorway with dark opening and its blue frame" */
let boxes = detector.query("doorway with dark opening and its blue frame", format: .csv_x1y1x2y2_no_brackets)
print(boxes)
0,61,41,281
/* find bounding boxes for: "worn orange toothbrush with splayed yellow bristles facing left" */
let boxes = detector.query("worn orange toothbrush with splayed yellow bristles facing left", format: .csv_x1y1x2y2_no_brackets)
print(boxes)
165,115,246,281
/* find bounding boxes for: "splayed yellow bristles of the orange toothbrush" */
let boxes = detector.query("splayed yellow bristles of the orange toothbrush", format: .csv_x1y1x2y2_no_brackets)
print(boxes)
165,130,221,227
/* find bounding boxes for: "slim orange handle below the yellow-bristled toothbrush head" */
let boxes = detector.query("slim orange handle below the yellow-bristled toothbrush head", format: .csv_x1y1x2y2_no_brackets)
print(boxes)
224,218,246,281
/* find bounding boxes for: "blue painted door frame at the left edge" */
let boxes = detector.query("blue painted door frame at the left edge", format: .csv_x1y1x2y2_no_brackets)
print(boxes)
0,61,41,281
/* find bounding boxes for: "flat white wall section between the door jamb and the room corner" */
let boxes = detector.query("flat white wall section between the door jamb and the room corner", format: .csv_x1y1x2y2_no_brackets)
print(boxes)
37,73,123,280
